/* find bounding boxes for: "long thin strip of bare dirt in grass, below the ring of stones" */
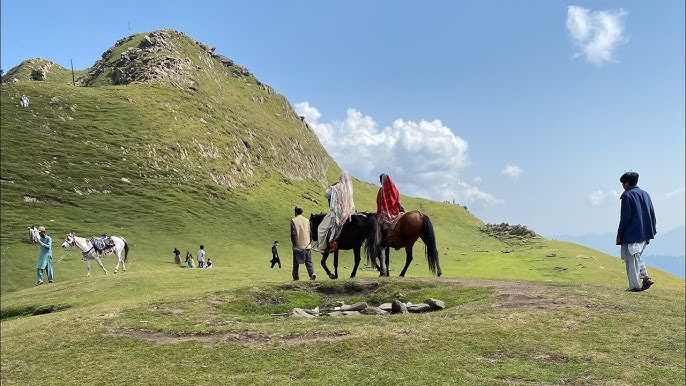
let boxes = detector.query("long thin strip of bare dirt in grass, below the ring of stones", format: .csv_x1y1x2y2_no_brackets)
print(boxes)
109,328,349,347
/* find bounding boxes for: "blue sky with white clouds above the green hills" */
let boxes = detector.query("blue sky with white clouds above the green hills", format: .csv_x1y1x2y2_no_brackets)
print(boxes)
0,0,686,247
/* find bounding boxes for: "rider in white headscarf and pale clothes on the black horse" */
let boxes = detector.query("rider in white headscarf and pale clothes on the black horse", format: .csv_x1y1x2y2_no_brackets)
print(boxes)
315,171,355,253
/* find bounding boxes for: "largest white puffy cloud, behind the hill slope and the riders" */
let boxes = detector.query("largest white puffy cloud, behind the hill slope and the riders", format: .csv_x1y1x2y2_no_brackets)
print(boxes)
294,102,503,206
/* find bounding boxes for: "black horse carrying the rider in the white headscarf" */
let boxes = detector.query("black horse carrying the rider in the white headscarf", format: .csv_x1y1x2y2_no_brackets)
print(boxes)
310,212,376,279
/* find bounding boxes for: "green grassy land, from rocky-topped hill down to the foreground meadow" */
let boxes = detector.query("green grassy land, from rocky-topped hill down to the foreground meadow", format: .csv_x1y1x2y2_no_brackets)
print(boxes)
0,30,685,385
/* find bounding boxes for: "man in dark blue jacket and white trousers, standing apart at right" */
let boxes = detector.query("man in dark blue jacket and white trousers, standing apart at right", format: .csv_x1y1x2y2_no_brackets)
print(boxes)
616,172,657,292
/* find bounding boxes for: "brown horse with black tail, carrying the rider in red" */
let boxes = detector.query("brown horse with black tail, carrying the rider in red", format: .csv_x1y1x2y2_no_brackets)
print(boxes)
367,210,442,276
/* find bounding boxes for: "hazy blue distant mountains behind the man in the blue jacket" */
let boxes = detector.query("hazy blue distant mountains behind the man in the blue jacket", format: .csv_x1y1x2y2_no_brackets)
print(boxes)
553,225,686,277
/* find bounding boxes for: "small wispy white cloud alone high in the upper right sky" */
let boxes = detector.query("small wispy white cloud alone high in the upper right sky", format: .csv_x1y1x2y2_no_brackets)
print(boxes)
567,5,628,65
